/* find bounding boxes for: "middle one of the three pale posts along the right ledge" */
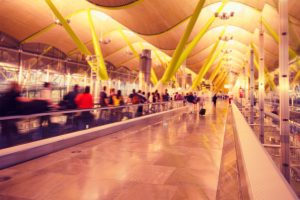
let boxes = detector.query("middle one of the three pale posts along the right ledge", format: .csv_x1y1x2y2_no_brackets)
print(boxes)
258,25,265,144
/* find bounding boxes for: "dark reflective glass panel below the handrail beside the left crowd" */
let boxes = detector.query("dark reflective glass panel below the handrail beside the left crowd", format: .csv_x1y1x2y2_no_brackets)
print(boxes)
0,101,184,148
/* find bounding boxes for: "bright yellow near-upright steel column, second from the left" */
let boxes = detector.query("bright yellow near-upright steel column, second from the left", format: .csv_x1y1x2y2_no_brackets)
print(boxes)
87,9,108,80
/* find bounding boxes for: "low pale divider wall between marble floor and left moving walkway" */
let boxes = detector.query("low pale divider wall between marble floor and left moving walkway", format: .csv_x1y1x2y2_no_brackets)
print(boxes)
0,106,186,169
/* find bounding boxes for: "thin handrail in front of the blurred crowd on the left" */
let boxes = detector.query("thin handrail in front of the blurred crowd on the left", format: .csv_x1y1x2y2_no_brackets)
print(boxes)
0,101,183,121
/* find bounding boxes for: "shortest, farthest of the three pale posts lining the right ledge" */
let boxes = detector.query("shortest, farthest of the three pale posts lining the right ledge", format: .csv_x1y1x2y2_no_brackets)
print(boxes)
249,49,255,124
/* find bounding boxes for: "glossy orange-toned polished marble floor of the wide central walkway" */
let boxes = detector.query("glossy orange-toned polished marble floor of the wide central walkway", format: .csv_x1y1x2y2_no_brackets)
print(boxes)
0,103,227,200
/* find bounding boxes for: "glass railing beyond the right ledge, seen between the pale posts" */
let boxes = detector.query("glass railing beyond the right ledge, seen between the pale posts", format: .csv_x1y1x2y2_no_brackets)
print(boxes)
235,100,300,196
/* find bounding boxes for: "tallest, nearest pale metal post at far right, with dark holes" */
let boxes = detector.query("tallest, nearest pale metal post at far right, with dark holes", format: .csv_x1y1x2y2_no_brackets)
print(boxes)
279,0,290,182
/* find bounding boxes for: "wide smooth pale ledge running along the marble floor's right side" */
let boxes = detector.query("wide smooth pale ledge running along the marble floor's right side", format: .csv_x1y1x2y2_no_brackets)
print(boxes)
232,104,298,200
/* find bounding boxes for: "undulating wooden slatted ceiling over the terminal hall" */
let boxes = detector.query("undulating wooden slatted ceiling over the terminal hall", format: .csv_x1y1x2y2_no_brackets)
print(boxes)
0,0,300,79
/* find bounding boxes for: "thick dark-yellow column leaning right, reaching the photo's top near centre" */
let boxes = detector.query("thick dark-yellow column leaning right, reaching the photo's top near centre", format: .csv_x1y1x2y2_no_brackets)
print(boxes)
161,0,205,84
